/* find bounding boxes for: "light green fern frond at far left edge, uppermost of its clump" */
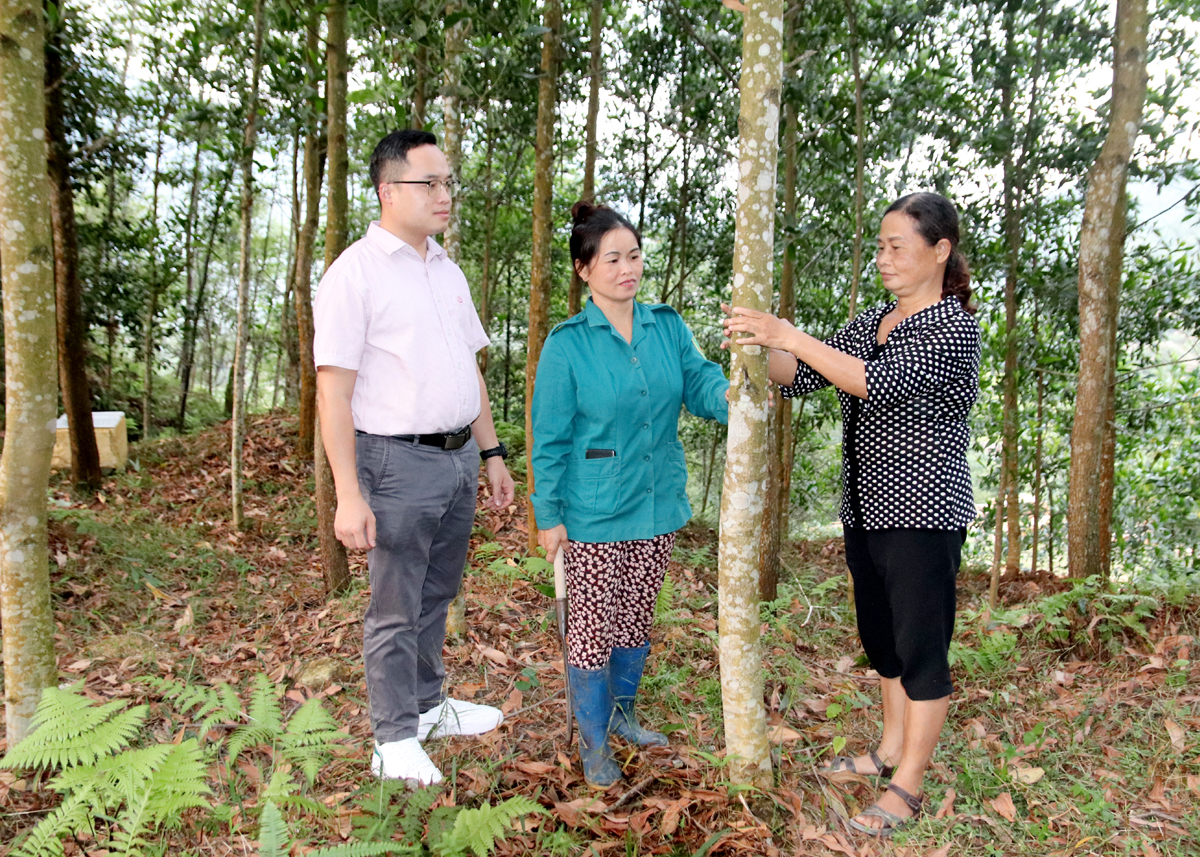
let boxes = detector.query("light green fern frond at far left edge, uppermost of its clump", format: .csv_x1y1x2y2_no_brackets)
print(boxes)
0,688,146,769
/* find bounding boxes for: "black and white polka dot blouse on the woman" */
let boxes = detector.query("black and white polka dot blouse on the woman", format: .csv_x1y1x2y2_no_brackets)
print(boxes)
780,296,980,529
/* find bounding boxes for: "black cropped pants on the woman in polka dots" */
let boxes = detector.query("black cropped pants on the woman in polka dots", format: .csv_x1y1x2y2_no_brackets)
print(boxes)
845,527,966,700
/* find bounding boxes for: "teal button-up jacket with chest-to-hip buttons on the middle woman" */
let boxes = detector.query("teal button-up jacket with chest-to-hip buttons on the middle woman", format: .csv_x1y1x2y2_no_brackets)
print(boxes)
530,299,730,541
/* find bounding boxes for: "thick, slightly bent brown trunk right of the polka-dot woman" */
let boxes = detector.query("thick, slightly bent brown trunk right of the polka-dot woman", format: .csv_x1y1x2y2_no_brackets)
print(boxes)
1067,0,1150,579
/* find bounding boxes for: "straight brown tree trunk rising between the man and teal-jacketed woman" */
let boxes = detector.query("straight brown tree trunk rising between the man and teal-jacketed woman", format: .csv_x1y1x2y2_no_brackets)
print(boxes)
526,0,563,550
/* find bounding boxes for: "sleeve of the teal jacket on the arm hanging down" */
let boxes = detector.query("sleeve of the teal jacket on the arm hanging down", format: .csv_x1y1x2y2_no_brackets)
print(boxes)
529,337,576,529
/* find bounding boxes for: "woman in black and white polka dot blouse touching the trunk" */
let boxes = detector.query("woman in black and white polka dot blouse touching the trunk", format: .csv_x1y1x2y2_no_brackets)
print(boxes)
725,193,980,835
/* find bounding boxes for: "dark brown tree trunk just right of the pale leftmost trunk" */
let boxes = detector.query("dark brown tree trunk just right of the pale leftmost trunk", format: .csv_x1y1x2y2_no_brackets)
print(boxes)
46,18,101,493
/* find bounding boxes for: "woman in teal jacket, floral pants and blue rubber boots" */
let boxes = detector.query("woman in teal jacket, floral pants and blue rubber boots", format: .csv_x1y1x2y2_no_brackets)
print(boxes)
530,202,728,787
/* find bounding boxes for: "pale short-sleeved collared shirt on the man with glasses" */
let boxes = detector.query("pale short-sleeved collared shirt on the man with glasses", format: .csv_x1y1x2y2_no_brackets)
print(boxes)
313,221,488,435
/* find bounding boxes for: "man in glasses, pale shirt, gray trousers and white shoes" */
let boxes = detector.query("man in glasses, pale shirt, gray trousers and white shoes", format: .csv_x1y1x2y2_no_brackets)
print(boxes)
313,130,514,785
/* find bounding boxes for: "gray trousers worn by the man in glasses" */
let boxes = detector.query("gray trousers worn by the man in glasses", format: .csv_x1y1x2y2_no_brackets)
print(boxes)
355,433,479,744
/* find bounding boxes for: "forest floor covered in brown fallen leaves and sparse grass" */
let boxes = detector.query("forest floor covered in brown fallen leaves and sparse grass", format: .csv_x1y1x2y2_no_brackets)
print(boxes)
0,414,1200,857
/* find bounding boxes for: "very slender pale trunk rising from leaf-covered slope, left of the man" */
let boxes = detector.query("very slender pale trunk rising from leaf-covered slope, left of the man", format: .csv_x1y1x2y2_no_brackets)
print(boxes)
229,0,264,529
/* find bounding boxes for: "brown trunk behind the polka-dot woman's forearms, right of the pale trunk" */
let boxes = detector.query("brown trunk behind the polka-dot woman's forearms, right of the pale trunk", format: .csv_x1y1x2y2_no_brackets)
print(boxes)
758,28,798,601
